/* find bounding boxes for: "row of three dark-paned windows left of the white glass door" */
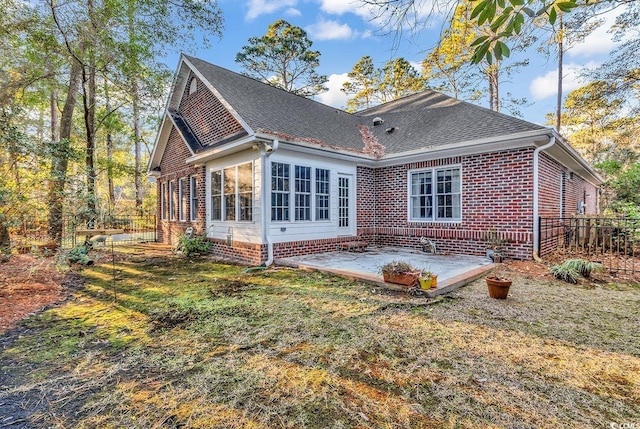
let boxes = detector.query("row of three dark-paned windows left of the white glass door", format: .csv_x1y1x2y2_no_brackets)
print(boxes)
271,162,331,221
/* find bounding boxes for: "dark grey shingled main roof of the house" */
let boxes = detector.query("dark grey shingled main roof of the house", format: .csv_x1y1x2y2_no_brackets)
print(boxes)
184,55,546,154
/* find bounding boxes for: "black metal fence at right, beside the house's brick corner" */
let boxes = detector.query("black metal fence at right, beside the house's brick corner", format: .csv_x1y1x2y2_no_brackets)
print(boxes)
538,217,640,273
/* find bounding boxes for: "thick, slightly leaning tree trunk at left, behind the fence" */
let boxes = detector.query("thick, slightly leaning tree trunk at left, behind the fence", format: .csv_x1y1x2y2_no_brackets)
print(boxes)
47,59,82,243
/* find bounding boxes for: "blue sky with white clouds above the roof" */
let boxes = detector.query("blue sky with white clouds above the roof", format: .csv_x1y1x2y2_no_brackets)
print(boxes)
167,0,628,124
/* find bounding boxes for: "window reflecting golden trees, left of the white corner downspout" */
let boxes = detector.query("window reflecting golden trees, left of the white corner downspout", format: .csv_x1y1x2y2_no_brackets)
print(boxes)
211,162,253,222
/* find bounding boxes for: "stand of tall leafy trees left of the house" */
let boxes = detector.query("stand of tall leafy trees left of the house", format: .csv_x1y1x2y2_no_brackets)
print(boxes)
0,0,222,244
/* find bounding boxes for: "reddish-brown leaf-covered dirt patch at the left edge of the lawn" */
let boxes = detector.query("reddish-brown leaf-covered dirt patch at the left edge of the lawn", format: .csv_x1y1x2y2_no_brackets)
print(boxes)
0,255,66,333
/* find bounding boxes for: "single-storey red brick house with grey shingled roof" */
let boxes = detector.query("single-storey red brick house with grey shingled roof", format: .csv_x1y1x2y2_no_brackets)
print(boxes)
148,55,601,264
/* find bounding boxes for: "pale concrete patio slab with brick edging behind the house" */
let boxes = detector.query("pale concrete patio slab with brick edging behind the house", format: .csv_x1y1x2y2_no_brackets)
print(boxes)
275,246,494,297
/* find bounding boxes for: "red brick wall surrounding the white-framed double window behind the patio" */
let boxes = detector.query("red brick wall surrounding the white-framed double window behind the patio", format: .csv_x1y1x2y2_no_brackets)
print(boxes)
358,148,533,259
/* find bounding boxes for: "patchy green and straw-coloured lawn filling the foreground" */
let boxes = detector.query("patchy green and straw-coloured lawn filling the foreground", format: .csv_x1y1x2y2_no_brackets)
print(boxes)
0,251,640,428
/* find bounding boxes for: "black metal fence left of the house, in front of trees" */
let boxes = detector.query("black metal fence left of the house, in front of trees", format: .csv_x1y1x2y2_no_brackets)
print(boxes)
10,214,158,251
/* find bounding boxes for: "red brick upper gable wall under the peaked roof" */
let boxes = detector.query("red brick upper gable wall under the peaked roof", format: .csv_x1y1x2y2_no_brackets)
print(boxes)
180,73,244,146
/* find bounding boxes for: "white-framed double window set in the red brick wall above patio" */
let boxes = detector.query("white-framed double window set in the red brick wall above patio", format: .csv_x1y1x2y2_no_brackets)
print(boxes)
409,167,462,222
